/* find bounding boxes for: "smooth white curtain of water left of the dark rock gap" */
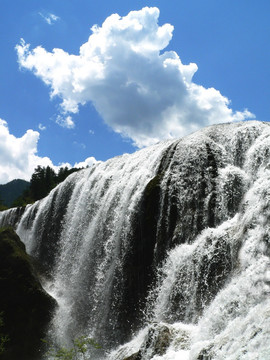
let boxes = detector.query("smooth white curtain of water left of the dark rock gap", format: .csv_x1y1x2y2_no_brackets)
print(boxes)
47,144,174,348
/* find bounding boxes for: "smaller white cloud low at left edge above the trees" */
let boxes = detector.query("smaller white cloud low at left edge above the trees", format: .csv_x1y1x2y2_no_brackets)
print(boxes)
0,119,96,184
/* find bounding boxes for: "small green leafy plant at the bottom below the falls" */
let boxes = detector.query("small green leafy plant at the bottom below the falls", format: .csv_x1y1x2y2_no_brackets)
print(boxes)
43,336,101,360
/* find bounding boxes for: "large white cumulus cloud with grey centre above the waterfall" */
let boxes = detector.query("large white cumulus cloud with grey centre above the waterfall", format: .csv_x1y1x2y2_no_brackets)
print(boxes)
16,7,254,147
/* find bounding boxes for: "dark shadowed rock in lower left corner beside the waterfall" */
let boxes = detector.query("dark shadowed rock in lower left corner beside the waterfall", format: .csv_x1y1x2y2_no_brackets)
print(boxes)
0,228,56,360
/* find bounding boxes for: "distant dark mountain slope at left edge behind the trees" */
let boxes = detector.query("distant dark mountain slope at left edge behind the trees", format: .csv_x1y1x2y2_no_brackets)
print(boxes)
0,179,30,207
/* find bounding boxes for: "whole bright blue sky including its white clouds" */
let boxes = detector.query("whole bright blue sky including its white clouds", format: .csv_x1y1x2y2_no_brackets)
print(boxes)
0,0,270,183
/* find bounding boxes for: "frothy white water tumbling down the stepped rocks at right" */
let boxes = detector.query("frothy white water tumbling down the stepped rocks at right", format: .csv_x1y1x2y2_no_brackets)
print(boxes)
106,121,270,360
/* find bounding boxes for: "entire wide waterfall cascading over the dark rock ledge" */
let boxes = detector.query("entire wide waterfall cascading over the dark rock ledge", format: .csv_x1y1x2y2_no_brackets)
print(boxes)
0,121,270,360
